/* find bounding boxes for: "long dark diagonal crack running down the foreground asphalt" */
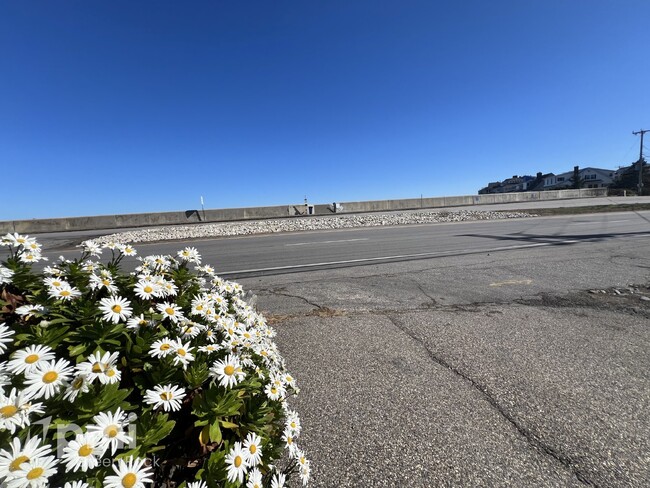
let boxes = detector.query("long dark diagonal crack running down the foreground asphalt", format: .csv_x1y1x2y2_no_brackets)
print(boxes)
384,314,598,487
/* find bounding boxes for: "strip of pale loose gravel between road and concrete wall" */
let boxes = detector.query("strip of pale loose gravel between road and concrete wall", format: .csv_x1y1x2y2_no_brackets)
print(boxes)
93,210,534,244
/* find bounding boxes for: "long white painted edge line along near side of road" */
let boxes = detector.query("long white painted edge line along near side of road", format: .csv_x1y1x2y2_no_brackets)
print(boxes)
219,239,580,275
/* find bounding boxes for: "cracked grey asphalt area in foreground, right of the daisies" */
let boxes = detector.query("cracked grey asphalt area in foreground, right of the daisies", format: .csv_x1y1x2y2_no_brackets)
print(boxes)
240,233,650,487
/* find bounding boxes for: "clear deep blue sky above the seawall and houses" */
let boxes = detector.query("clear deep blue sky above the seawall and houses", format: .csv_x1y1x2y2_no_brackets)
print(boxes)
0,0,650,220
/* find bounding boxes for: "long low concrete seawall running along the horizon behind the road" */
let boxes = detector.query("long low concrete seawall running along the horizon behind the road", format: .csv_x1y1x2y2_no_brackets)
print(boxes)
0,188,607,234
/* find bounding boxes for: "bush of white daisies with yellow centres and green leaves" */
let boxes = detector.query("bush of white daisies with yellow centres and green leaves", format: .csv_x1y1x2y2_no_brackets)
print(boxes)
0,234,310,488
